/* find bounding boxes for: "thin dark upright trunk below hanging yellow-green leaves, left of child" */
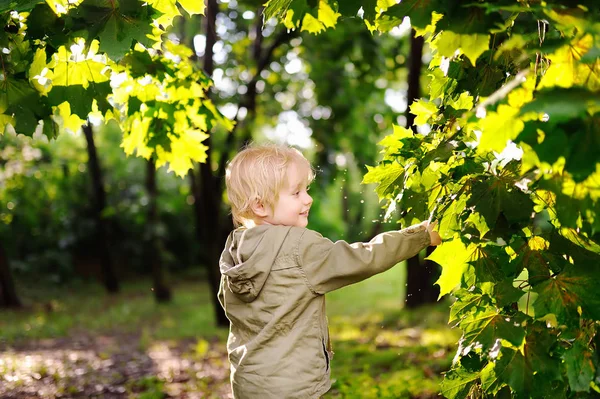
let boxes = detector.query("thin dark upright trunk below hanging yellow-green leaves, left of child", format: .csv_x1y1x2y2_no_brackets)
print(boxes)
146,158,171,303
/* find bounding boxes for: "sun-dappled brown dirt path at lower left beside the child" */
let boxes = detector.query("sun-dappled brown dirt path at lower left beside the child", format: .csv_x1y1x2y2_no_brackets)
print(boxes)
0,334,232,399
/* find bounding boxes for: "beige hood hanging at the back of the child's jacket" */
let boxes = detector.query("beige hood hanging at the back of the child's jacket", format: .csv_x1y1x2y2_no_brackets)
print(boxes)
219,225,291,302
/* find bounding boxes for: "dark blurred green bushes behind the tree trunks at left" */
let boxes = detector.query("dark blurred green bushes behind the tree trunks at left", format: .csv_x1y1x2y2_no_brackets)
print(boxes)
0,125,200,285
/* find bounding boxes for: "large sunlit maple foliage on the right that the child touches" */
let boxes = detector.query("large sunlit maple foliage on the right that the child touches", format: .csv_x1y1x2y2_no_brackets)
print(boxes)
266,0,600,398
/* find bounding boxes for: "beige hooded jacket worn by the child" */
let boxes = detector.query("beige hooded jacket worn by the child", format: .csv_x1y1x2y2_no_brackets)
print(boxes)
219,225,430,399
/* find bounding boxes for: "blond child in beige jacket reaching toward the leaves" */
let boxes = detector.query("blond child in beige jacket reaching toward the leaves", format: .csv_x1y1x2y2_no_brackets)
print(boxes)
219,145,441,399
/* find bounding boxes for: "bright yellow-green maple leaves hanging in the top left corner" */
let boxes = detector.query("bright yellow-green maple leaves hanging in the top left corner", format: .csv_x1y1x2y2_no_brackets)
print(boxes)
0,0,232,175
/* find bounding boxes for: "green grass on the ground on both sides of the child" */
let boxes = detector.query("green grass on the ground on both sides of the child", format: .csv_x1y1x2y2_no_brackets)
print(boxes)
0,267,459,399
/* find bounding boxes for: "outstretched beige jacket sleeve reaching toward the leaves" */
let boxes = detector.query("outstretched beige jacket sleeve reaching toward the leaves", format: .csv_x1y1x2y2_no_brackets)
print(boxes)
297,225,431,294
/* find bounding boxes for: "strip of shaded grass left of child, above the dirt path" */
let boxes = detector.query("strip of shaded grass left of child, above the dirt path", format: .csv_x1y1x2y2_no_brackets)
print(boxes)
0,274,227,344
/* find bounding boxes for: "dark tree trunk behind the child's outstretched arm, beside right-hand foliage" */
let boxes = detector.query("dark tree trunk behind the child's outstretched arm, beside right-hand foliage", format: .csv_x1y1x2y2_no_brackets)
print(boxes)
405,29,439,308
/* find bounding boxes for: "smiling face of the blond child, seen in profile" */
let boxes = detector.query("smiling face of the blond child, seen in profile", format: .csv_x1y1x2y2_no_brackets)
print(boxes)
264,162,312,227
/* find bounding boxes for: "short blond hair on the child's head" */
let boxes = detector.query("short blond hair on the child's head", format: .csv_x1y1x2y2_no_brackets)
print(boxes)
225,144,314,227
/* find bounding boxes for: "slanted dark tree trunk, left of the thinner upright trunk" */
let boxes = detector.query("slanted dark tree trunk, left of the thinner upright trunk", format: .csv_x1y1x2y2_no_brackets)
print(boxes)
82,122,119,293
